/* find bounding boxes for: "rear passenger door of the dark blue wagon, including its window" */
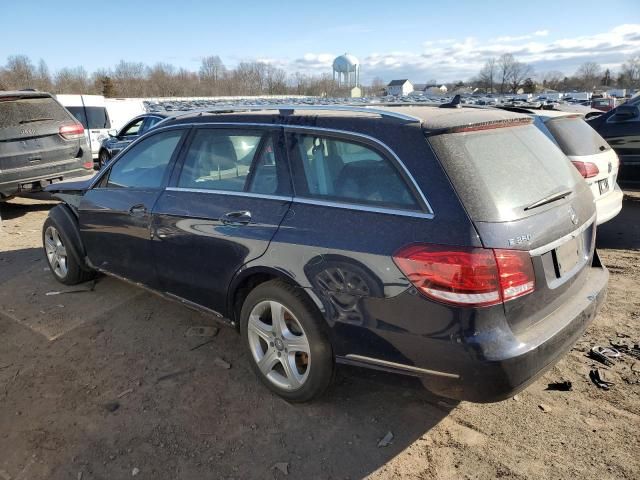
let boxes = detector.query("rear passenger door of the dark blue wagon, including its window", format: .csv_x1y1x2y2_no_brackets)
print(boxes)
152,126,291,313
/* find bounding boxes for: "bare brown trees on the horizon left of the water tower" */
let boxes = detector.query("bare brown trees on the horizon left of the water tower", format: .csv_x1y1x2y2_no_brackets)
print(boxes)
0,55,356,97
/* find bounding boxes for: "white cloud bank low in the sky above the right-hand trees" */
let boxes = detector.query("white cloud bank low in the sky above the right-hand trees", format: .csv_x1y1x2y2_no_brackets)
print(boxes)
287,24,640,82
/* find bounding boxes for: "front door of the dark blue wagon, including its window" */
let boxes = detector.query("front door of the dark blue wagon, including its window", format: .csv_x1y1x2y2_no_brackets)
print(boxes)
79,129,185,287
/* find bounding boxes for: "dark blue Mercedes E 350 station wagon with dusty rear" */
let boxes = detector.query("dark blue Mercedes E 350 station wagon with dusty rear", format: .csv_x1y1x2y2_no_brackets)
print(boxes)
43,106,608,402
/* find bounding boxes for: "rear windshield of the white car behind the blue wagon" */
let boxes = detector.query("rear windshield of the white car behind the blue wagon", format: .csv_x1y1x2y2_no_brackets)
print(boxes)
545,117,611,156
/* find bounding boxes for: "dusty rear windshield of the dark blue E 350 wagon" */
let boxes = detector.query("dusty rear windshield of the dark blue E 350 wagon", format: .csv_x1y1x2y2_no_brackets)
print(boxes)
429,125,582,222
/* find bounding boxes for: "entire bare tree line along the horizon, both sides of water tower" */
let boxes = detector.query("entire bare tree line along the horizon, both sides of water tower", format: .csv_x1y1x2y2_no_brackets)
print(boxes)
0,53,640,97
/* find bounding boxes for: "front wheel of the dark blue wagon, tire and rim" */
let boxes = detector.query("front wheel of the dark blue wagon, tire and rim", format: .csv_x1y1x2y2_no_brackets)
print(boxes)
42,217,96,285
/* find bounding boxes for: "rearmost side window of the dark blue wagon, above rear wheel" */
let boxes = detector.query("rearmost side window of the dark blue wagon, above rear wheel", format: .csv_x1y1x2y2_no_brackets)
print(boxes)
292,134,420,210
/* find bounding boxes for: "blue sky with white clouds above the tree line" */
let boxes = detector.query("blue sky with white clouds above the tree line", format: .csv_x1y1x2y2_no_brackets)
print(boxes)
0,0,640,83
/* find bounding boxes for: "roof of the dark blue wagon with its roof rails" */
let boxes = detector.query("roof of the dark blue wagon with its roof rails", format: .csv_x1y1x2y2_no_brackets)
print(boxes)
165,104,527,130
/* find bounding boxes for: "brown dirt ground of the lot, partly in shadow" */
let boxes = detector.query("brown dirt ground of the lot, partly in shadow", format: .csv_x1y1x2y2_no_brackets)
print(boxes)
0,194,640,480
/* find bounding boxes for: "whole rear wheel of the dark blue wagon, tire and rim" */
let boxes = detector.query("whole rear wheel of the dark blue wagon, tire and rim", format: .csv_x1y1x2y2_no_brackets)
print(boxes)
240,280,333,402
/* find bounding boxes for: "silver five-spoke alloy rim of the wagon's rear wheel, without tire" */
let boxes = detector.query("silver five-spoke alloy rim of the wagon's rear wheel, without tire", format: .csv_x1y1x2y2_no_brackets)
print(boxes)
247,300,311,391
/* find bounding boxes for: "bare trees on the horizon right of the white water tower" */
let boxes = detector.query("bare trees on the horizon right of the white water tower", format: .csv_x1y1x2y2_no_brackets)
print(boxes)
470,53,640,94
